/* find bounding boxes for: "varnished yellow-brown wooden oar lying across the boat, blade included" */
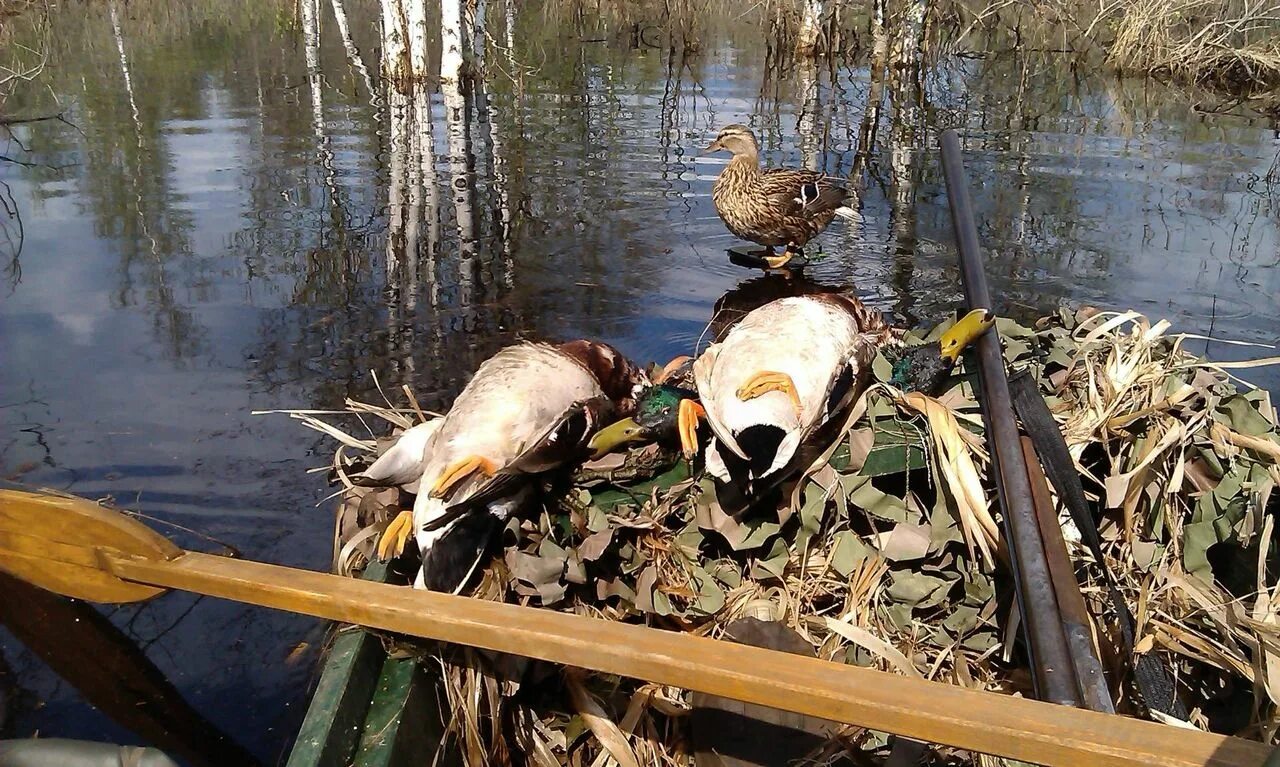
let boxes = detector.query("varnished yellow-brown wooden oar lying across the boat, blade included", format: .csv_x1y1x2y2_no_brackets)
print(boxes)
0,490,1271,767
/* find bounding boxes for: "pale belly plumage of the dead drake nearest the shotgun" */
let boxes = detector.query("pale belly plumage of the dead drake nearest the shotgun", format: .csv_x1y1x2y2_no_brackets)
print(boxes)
694,297,867,480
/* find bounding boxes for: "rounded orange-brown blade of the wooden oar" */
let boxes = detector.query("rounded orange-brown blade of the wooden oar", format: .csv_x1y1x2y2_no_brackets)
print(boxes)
0,489,182,603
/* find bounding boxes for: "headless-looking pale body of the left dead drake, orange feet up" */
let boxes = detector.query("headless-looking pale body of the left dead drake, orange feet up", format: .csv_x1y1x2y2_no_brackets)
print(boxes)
360,341,650,593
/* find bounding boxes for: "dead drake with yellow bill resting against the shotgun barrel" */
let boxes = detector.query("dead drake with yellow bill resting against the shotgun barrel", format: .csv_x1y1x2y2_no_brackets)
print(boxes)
694,293,995,513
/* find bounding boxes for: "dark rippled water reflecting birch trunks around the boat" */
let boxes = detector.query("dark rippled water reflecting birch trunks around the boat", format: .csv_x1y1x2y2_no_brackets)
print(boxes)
0,0,1280,762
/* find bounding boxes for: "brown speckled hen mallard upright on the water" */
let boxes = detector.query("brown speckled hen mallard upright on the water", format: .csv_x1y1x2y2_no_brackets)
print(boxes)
704,123,859,269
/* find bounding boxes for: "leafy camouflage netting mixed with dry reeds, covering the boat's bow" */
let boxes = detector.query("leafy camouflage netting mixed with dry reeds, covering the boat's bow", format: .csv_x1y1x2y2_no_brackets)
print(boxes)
288,310,1280,766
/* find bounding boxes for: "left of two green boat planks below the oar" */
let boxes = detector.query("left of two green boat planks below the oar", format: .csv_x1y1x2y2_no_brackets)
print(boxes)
288,562,387,767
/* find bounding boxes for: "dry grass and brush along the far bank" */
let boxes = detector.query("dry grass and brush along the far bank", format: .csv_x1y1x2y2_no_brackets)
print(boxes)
0,0,1280,118
